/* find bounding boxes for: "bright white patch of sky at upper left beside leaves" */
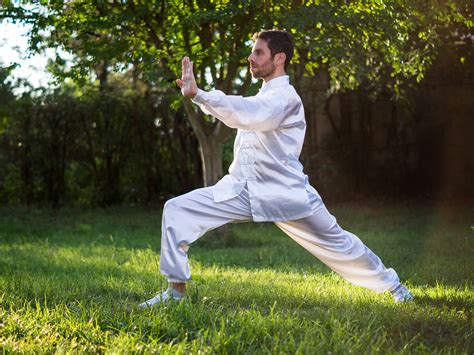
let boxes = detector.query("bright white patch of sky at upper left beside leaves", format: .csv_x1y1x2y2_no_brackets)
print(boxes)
0,21,54,88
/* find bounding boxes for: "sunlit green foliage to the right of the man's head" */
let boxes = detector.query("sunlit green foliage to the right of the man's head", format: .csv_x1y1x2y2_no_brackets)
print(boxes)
280,0,473,97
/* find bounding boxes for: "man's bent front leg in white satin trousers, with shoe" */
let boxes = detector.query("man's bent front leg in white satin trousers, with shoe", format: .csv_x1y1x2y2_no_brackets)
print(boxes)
140,187,252,308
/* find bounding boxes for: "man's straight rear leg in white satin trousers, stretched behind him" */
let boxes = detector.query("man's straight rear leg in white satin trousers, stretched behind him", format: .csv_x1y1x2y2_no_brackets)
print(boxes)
275,205,406,292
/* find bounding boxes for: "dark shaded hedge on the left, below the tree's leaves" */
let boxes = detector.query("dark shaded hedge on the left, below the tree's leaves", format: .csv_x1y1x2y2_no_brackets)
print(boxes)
0,74,199,207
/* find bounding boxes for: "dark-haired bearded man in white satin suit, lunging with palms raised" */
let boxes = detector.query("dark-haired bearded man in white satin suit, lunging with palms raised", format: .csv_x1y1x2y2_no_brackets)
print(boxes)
139,30,413,308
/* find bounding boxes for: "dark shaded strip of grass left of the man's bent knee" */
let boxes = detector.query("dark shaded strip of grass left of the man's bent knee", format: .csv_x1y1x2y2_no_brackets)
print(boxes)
0,207,161,251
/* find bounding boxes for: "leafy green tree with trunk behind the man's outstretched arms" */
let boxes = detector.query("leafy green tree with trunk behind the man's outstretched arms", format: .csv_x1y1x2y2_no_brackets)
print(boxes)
2,0,472,189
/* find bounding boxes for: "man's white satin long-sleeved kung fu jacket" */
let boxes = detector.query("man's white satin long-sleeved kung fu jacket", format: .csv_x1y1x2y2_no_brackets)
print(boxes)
193,75,322,222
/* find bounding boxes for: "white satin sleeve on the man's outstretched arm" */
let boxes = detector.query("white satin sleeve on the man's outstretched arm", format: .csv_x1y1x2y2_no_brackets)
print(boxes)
193,89,288,131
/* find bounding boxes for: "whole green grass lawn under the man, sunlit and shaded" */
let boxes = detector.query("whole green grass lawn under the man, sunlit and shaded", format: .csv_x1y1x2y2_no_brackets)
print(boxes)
0,205,474,354
